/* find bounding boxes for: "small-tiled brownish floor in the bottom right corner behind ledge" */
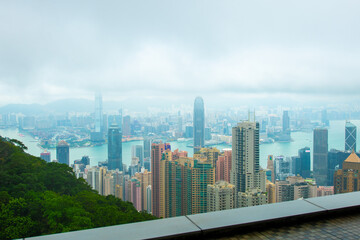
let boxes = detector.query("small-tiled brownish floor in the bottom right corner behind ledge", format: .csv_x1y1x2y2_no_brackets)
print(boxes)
213,213,360,240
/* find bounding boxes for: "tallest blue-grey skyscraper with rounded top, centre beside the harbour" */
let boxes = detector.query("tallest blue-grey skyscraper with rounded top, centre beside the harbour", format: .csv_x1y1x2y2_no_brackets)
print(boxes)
193,97,205,153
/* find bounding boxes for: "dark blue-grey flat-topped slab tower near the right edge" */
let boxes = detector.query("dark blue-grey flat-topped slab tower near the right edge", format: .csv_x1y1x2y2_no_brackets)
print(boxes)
313,128,328,186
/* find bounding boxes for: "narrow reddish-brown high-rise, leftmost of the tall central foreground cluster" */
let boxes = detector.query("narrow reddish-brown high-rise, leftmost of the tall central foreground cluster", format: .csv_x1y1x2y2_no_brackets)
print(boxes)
151,143,169,217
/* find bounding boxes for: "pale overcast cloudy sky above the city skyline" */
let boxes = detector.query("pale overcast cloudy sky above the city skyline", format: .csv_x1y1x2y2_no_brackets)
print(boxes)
0,0,360,106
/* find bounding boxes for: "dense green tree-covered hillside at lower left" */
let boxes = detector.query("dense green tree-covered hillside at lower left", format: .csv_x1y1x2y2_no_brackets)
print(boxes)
0,137,155,239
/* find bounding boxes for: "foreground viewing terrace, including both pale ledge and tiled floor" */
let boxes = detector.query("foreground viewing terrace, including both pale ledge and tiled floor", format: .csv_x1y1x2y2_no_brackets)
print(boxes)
26,192,360,240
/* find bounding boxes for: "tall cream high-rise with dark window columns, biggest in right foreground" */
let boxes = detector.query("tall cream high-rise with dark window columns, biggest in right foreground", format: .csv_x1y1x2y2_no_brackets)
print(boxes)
230,121,267,207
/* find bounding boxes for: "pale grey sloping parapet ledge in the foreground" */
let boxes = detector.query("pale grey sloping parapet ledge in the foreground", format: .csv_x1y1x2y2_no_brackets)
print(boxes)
26,192,360,240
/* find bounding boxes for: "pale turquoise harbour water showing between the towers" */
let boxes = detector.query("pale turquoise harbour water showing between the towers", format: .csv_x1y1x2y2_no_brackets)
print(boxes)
0,120,360,168
